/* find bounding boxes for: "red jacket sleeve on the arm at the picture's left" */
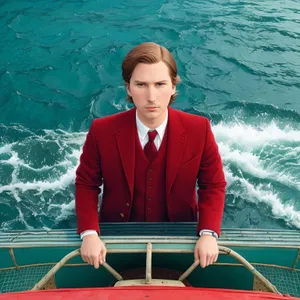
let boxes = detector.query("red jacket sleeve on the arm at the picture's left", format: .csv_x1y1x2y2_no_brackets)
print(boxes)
75,121,102,234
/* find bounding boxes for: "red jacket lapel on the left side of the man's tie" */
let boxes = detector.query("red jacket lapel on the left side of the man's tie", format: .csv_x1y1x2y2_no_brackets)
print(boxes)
116,108,136,199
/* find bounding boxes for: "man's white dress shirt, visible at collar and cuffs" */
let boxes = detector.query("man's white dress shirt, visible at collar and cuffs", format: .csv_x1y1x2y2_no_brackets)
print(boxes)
80,110,217,239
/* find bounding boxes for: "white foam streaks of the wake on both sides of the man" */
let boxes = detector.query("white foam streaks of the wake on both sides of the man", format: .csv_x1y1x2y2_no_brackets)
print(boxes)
0,123,300,228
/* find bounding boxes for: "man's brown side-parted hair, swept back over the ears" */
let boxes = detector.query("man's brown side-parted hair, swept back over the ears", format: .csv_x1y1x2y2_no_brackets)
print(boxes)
122,42,181,104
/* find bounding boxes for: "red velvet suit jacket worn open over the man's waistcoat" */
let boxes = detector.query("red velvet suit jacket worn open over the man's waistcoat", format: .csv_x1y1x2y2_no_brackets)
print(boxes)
75,107,226,234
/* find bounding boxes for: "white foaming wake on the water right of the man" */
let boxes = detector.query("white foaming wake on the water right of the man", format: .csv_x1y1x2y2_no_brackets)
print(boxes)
213,122,300,228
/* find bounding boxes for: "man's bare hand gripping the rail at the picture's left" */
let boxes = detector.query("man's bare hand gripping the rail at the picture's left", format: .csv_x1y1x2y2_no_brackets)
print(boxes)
80,234,106,269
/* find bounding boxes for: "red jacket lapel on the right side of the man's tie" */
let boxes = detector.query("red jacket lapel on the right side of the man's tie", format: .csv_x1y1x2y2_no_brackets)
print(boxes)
166,108,186,198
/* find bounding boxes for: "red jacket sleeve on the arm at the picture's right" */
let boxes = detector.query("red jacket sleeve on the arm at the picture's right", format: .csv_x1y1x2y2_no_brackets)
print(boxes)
197,119,226,236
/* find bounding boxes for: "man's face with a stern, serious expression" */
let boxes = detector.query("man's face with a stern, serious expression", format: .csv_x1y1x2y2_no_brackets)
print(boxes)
126,61,176,123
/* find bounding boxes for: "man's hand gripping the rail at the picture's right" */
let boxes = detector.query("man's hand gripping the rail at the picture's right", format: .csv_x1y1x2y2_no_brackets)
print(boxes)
194,234,219,268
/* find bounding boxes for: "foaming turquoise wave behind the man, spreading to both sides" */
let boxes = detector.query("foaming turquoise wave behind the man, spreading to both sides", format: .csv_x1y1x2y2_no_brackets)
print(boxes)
0,120,300,228
